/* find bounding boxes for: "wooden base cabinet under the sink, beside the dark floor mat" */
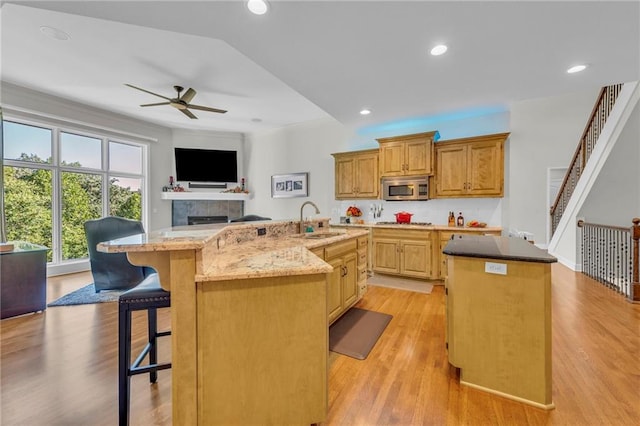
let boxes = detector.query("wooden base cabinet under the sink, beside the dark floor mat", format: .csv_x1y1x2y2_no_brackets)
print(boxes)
324,238,359,324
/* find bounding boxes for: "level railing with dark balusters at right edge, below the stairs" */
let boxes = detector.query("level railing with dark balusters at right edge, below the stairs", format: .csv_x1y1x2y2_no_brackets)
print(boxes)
578,218,640,302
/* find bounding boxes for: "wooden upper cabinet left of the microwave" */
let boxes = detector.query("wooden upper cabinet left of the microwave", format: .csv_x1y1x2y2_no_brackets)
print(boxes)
332,149,380,200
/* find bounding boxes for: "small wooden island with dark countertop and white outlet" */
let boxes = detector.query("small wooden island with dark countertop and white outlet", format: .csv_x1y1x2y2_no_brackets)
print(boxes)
443,236,557,409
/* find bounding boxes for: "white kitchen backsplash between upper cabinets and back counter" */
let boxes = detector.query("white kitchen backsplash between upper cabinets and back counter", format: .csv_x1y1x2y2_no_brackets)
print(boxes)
331,198,502,226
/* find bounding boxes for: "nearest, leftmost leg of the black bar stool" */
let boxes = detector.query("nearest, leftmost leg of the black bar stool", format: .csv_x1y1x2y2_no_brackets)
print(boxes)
118,303,131,426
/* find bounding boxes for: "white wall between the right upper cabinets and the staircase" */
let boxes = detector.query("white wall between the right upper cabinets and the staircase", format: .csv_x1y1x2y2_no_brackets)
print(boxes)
503,88,600,246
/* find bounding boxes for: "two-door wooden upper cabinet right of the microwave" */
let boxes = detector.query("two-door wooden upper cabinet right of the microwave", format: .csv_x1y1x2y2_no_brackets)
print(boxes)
434,133,509,198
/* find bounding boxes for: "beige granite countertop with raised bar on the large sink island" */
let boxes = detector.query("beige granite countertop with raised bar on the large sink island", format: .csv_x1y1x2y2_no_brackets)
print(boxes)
98,220,369,282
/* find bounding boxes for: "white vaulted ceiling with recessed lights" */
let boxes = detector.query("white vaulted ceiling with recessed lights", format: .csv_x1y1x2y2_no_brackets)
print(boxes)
0,0,640,133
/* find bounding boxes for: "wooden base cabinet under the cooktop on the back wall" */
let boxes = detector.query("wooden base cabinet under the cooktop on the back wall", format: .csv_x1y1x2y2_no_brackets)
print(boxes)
372,229,434,279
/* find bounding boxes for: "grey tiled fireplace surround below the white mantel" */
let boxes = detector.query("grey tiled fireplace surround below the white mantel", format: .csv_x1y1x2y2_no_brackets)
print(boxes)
171,200,244,226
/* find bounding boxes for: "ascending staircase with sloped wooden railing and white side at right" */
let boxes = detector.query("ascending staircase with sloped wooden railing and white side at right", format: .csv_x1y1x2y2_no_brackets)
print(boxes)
548,82,640,270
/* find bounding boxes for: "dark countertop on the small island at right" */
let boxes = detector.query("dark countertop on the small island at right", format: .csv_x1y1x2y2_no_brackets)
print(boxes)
442,235,558,263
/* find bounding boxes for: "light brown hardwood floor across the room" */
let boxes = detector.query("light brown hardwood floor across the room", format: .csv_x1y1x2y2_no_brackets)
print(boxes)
0,264,640,426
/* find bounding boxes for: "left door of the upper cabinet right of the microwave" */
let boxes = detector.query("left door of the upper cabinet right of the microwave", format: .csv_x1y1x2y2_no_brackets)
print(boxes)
436,145,467,197
